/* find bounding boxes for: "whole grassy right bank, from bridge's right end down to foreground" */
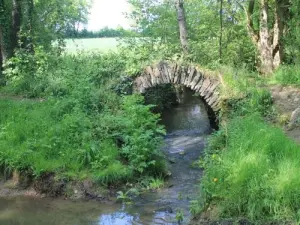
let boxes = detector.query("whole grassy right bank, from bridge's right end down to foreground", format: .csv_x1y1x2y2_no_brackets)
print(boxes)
191,69,300,224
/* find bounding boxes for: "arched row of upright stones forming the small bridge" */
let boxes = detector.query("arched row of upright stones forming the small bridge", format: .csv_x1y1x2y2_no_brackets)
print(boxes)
133,62,222,113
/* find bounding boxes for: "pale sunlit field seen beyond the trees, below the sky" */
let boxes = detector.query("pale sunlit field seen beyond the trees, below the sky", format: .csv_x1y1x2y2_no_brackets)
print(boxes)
66,38,118,53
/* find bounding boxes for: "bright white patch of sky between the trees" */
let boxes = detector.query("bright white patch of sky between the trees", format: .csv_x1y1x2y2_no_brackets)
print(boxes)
87,0,129,31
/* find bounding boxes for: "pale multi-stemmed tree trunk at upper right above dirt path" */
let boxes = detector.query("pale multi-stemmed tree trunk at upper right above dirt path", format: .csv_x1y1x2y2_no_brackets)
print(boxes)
243,0,290,74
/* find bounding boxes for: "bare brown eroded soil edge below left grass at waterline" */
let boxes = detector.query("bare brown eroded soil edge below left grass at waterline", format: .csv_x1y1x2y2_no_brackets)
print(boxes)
0,172,111,202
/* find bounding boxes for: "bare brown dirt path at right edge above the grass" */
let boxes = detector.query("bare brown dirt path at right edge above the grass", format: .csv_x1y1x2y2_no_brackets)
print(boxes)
270,85,300,143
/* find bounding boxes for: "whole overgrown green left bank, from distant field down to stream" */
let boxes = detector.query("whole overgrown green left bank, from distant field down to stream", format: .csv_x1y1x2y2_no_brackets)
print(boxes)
0,49,166,190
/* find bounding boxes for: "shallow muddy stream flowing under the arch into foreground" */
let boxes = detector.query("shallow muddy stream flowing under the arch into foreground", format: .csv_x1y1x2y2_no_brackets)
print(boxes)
0,92,210,225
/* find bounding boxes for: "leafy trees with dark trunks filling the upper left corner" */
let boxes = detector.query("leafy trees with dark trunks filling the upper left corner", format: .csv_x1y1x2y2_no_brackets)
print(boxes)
0,0,90,80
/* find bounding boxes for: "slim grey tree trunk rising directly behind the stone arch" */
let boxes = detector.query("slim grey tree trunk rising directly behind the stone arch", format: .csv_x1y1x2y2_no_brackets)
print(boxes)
176,0,189,54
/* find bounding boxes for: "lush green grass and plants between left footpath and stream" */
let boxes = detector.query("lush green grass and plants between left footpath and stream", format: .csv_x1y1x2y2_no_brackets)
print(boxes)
0,92,164,184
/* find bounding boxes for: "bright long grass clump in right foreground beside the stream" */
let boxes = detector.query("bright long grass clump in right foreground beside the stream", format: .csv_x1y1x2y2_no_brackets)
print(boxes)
198,115,300,221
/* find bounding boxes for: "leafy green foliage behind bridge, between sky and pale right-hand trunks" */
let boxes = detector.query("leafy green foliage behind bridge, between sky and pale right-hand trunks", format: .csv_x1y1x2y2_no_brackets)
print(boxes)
124,0,255,69
